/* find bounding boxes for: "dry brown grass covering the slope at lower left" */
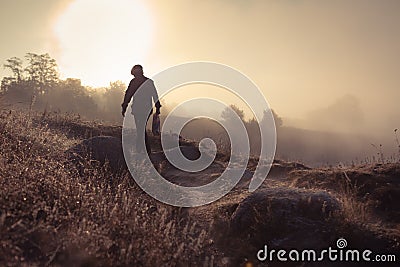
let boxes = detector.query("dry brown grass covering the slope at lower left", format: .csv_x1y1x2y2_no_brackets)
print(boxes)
0,112,208,266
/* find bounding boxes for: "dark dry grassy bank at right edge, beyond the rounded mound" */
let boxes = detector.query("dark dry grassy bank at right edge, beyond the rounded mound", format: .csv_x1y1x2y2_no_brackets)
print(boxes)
290,163,400,247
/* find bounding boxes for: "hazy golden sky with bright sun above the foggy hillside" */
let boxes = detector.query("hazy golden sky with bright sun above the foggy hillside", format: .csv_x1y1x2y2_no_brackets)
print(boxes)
0,0,400,135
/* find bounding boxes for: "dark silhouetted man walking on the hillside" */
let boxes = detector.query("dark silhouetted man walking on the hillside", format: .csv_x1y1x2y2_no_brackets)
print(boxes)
121,65,161,153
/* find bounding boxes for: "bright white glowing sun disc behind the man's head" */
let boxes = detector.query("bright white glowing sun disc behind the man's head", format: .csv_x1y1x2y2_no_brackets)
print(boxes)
54,0,153,86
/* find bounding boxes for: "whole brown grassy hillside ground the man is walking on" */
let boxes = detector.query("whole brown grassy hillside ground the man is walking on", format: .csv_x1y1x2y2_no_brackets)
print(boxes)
0,110,400,266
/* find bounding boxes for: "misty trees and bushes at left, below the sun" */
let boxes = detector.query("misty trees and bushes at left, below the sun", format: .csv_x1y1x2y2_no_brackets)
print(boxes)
0,53,126,122
